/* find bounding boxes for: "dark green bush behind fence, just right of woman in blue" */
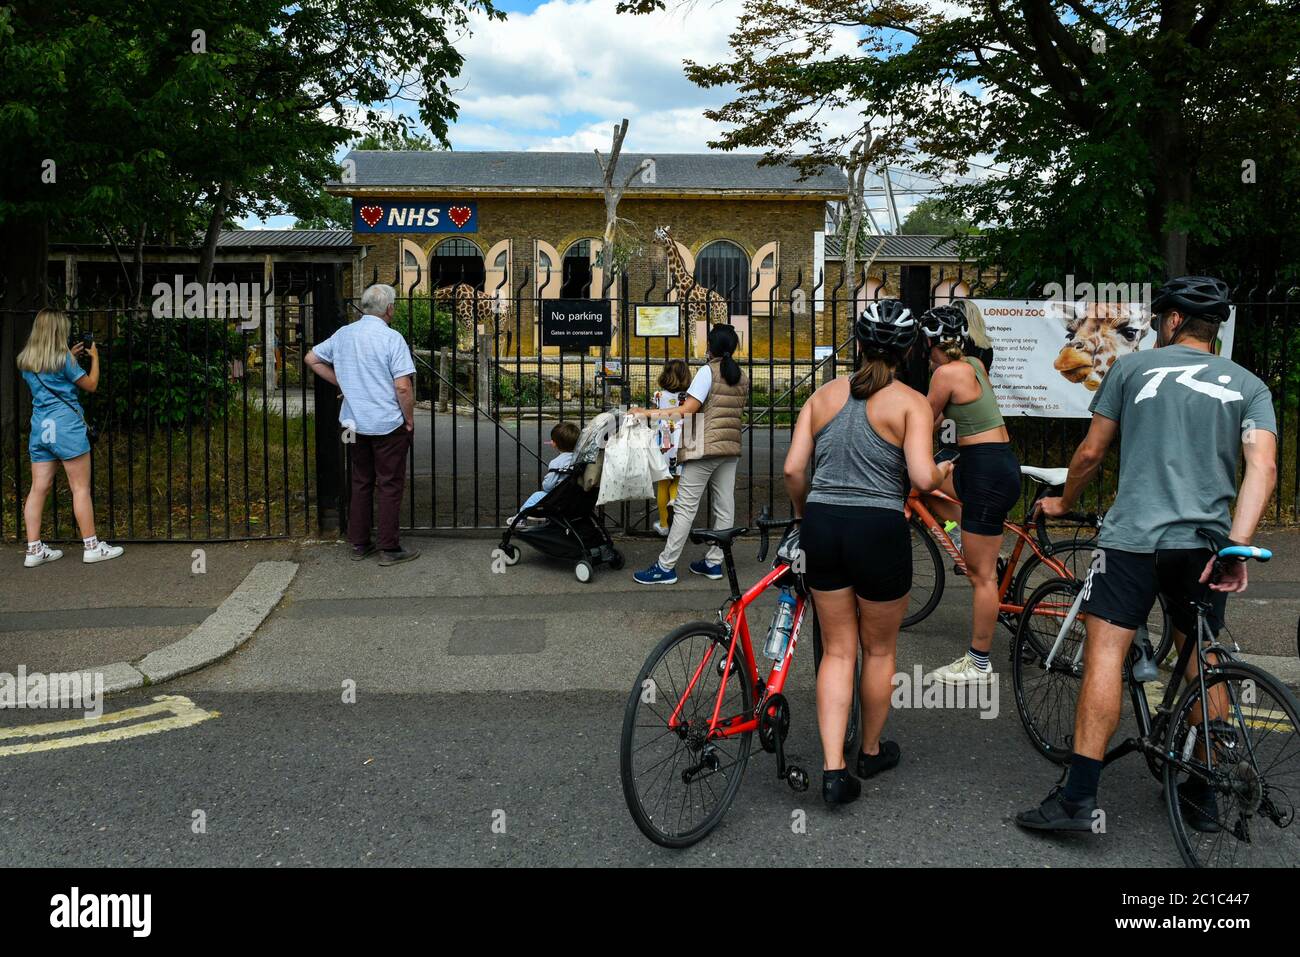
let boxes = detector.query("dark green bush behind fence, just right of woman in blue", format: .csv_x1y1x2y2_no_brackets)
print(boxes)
95,313,239,430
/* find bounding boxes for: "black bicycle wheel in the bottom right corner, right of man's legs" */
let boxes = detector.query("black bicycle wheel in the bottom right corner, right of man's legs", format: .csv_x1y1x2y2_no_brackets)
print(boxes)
1165,662,1300,867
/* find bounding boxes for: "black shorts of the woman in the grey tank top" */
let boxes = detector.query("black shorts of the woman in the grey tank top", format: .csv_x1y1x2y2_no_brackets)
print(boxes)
800,502,911,602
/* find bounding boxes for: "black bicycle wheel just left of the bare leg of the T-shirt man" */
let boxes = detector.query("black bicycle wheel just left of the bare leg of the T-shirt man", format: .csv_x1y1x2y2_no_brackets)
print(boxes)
1011,579,1084,765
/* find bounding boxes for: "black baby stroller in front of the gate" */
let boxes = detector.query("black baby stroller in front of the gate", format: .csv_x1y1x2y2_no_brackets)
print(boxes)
499,412,623,583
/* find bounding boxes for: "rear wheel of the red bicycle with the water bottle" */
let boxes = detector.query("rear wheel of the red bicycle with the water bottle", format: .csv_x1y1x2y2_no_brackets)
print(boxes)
619,622,754,848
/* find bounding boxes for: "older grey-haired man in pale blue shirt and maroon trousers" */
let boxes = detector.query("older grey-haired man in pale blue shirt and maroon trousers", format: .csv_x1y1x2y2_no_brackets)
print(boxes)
306,285,420,566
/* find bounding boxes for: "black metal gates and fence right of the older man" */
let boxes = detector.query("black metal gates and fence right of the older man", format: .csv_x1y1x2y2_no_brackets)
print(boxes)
354,257,1300,532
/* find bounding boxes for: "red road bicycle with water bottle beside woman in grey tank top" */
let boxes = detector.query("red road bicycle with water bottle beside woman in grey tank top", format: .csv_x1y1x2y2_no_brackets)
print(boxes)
619,518,813,848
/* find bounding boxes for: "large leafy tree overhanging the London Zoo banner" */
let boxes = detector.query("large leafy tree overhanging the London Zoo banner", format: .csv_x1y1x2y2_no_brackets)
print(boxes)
639,0,1300,287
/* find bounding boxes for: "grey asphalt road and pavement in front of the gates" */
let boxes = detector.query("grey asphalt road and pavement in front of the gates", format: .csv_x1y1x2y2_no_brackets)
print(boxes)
0,532,1300,867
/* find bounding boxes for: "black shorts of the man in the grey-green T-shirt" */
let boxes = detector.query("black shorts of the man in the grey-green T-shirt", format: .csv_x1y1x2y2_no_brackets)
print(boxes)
1082,549,1227,635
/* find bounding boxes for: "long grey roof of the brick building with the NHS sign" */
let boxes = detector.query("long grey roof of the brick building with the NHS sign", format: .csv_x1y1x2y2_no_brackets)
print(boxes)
330,150,845,196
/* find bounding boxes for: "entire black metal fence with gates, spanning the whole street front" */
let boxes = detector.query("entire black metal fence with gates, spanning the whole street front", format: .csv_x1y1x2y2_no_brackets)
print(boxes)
0,264,1300,541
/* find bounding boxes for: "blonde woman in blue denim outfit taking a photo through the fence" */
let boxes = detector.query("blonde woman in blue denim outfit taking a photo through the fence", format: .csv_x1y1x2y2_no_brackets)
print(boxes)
18,309,122,568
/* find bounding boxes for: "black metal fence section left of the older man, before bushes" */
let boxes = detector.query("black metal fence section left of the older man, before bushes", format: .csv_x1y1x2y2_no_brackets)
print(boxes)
0,269,325,541
